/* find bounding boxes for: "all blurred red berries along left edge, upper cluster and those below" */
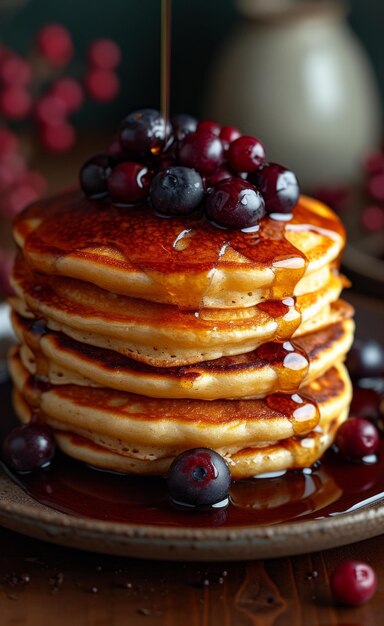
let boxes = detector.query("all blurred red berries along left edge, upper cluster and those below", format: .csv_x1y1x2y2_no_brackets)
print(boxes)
0,24,121,295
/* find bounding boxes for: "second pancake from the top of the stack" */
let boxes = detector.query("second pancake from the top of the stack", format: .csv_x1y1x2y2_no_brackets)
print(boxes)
12,258,343,367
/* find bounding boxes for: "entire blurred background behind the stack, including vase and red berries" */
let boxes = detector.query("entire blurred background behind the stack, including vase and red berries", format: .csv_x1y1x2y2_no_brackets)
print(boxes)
0,0,384,294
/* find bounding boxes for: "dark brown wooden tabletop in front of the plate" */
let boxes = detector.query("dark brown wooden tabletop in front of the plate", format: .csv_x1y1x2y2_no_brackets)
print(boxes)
0,529,384,626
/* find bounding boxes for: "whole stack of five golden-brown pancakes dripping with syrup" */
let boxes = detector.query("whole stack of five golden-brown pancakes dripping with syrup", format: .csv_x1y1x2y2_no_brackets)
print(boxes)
6,192,353,478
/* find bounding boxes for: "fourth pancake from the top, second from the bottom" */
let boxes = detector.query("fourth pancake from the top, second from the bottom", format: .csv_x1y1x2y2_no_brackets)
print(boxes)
10,348,350,452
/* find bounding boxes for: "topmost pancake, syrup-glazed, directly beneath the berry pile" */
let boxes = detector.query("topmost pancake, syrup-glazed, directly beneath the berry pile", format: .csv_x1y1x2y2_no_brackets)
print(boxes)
14,192,345,310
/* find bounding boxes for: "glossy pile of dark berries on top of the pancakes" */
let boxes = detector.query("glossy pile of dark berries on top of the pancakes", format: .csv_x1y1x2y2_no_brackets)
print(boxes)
80,109,300,229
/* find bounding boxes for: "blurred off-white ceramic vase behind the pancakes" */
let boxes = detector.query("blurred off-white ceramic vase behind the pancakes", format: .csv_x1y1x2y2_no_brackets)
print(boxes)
205,0,382,189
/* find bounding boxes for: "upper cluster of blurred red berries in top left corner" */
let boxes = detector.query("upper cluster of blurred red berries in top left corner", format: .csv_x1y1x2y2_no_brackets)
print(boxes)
0,24,121,152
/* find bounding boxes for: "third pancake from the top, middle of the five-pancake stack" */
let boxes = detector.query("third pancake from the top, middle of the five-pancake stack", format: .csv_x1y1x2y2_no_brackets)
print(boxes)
12,301,354,400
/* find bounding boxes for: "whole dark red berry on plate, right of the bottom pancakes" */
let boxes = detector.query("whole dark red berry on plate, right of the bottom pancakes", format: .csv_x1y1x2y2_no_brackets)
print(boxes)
335,417,379,460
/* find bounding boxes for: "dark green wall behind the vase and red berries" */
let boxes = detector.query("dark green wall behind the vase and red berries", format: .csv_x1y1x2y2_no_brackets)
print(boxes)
0,0,384,126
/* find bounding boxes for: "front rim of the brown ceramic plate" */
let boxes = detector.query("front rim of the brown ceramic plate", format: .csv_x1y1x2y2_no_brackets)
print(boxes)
0,466,384,561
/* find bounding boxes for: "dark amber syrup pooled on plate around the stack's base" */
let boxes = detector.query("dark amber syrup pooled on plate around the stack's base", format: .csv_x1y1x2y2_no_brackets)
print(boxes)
1,383,384,528
